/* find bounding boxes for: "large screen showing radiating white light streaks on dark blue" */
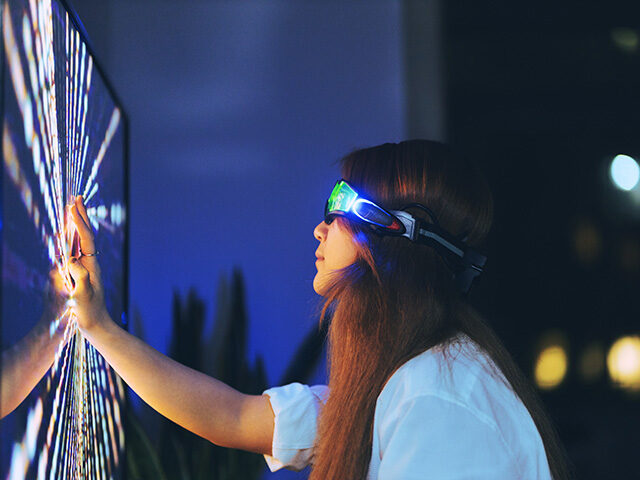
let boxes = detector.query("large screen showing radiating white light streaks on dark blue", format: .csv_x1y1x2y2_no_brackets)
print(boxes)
2,0,126,480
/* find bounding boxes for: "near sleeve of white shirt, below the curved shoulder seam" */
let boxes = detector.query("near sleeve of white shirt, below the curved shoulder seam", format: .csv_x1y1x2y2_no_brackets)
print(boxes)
378,395,522,480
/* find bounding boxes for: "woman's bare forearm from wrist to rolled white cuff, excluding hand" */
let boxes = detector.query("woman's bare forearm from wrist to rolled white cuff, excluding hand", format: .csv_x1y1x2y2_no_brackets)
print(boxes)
84,319,273,453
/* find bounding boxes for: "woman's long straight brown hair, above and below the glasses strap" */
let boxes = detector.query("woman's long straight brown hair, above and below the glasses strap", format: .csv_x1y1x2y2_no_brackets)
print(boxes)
310,140,570,480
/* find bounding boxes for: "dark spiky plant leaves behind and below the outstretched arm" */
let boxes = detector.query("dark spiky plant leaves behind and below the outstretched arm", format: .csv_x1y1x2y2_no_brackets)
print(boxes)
125,268,326,480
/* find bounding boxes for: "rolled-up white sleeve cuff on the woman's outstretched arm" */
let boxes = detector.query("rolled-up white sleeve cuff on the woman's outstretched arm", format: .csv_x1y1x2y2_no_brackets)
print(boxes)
263,383,329,472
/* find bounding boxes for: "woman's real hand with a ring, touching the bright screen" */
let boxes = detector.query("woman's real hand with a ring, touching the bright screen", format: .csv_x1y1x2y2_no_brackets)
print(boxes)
69,196,110,332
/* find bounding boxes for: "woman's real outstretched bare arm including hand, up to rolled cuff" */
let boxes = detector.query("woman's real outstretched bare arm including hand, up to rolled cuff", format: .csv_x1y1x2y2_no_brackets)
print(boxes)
69,197,274,454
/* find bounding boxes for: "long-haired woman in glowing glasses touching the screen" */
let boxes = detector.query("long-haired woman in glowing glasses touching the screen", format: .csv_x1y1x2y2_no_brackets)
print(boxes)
70,140,569,480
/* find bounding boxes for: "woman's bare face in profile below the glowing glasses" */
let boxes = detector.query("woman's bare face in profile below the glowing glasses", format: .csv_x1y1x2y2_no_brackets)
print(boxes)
313,220,357,295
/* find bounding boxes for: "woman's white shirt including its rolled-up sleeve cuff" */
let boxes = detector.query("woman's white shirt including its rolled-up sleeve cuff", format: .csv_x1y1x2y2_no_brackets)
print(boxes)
264,335,551,480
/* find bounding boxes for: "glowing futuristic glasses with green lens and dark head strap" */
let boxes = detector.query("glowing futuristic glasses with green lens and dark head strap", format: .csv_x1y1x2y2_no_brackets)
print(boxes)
324,179,487,293
